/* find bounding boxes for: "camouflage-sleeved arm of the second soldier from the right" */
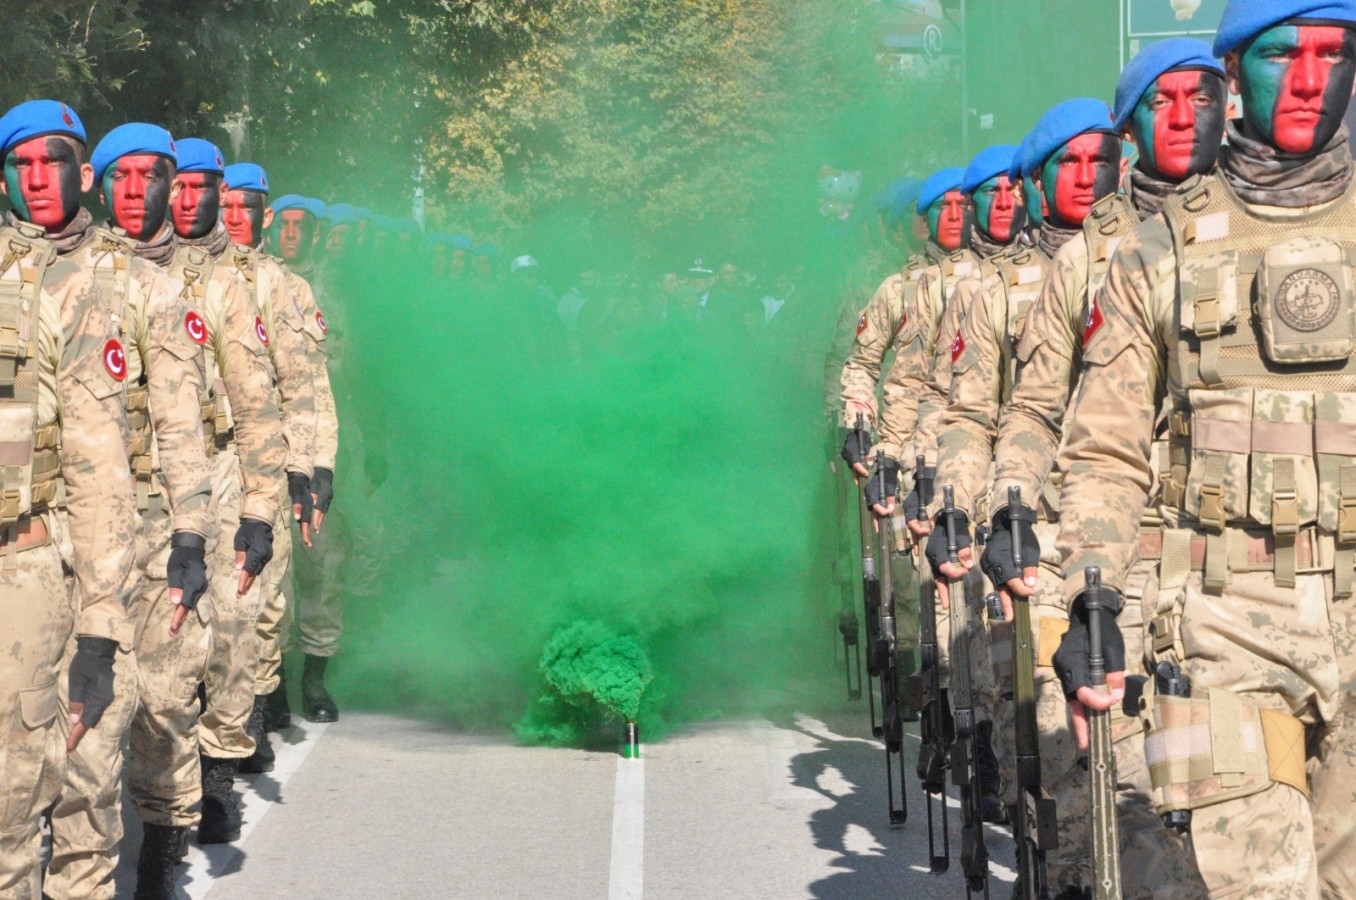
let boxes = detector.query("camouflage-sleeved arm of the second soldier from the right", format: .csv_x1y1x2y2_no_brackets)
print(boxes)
990,239,1085,520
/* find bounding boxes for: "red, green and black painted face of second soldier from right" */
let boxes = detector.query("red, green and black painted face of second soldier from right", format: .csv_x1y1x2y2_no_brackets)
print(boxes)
1130,69,1226,182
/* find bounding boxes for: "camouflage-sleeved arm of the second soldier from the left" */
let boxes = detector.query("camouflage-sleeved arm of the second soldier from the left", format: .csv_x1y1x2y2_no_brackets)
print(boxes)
136,264,212,538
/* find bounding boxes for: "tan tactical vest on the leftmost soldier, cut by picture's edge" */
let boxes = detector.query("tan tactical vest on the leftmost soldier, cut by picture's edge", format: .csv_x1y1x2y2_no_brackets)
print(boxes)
0,224,61,527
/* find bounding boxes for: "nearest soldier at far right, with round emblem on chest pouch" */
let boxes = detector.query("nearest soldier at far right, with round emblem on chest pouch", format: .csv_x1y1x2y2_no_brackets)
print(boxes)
1054,0,1356,897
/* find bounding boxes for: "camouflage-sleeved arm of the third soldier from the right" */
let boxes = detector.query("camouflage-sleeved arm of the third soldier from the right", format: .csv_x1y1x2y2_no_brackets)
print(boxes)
937,281,1003,520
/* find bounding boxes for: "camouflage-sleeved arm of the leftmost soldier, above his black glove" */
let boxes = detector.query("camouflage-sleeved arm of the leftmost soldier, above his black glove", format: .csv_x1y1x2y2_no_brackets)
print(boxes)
47,267,137,648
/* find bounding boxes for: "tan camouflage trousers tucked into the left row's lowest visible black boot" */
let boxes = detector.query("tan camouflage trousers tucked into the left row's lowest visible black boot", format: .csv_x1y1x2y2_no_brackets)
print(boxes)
127,496,212,825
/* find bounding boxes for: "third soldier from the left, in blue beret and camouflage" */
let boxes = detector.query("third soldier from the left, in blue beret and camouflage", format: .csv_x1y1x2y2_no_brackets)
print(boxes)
170,138,287,843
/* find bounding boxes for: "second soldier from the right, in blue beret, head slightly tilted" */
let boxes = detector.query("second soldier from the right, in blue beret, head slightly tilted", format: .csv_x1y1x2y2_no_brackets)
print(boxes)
982,38,1226,897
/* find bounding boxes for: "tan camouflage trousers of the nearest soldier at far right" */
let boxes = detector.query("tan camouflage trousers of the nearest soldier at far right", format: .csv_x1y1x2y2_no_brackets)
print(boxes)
1155,572,1356,899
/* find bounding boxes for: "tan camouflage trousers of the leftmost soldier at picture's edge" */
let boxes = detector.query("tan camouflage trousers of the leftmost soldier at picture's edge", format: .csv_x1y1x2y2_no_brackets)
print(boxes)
0,515,75,900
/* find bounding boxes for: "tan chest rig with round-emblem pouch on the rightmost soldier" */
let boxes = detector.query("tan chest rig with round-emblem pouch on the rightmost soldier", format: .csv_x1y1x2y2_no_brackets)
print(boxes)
1163,176,1356,596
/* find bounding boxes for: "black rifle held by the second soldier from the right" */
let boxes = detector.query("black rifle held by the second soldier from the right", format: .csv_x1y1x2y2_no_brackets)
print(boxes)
1008,487,1059,900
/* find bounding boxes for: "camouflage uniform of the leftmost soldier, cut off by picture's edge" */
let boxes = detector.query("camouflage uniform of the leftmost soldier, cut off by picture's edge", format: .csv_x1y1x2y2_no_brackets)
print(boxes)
0,225,137,899
